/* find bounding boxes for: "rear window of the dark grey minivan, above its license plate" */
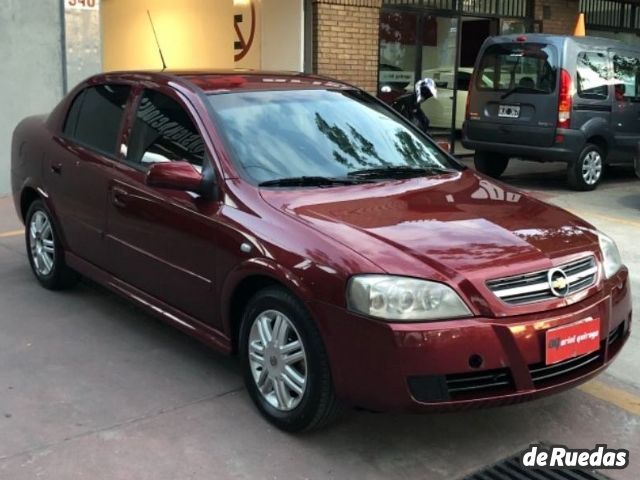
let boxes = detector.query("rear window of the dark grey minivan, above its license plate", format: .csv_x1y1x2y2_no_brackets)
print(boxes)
475,43,558,94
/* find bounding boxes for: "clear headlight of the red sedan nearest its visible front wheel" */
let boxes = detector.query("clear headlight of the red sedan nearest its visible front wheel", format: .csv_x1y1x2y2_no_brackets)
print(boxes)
347,275,471,321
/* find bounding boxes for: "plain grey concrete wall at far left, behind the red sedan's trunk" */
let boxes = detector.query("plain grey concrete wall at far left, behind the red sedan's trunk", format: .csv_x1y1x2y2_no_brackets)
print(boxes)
0,0,62,195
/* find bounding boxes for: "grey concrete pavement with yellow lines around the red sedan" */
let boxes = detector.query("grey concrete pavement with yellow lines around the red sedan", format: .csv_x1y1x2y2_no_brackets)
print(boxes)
0,164,640,480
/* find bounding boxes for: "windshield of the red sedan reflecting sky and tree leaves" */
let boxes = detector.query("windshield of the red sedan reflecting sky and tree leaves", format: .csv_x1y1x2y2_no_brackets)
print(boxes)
209,90,462,184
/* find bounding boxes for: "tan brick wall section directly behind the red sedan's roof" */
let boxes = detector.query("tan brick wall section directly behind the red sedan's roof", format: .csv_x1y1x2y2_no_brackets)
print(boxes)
313,0,382,93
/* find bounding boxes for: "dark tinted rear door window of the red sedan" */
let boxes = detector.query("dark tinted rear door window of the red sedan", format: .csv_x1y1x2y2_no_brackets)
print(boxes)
64,85,130,156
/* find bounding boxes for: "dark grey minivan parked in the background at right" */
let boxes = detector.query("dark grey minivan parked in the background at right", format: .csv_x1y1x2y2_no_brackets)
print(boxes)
462,34,640,190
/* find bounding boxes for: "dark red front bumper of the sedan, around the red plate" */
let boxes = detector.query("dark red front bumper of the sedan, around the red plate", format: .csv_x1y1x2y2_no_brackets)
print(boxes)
310,269,631,411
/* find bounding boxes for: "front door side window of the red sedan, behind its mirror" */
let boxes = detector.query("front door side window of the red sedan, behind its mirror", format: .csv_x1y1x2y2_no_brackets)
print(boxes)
127,90,205,170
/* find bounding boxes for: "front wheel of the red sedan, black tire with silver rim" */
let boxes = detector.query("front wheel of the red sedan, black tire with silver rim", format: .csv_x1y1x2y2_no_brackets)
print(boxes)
239,286,340,432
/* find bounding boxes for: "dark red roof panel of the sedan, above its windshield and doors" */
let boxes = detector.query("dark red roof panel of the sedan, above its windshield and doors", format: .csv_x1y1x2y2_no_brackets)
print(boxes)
97,70,356,94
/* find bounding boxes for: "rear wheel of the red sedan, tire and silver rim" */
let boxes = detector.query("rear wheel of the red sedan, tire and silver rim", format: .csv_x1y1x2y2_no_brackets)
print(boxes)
25,200,80,290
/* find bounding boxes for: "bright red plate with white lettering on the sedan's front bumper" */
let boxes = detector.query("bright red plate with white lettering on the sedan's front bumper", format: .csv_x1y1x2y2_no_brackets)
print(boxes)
545,317,600,365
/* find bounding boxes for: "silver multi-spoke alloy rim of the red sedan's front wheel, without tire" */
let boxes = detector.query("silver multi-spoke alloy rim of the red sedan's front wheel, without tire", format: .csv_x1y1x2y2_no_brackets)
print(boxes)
248,310,308,412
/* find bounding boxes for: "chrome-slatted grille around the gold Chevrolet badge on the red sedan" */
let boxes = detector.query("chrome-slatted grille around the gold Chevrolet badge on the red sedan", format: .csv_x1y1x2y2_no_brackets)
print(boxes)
487,256,598,305
